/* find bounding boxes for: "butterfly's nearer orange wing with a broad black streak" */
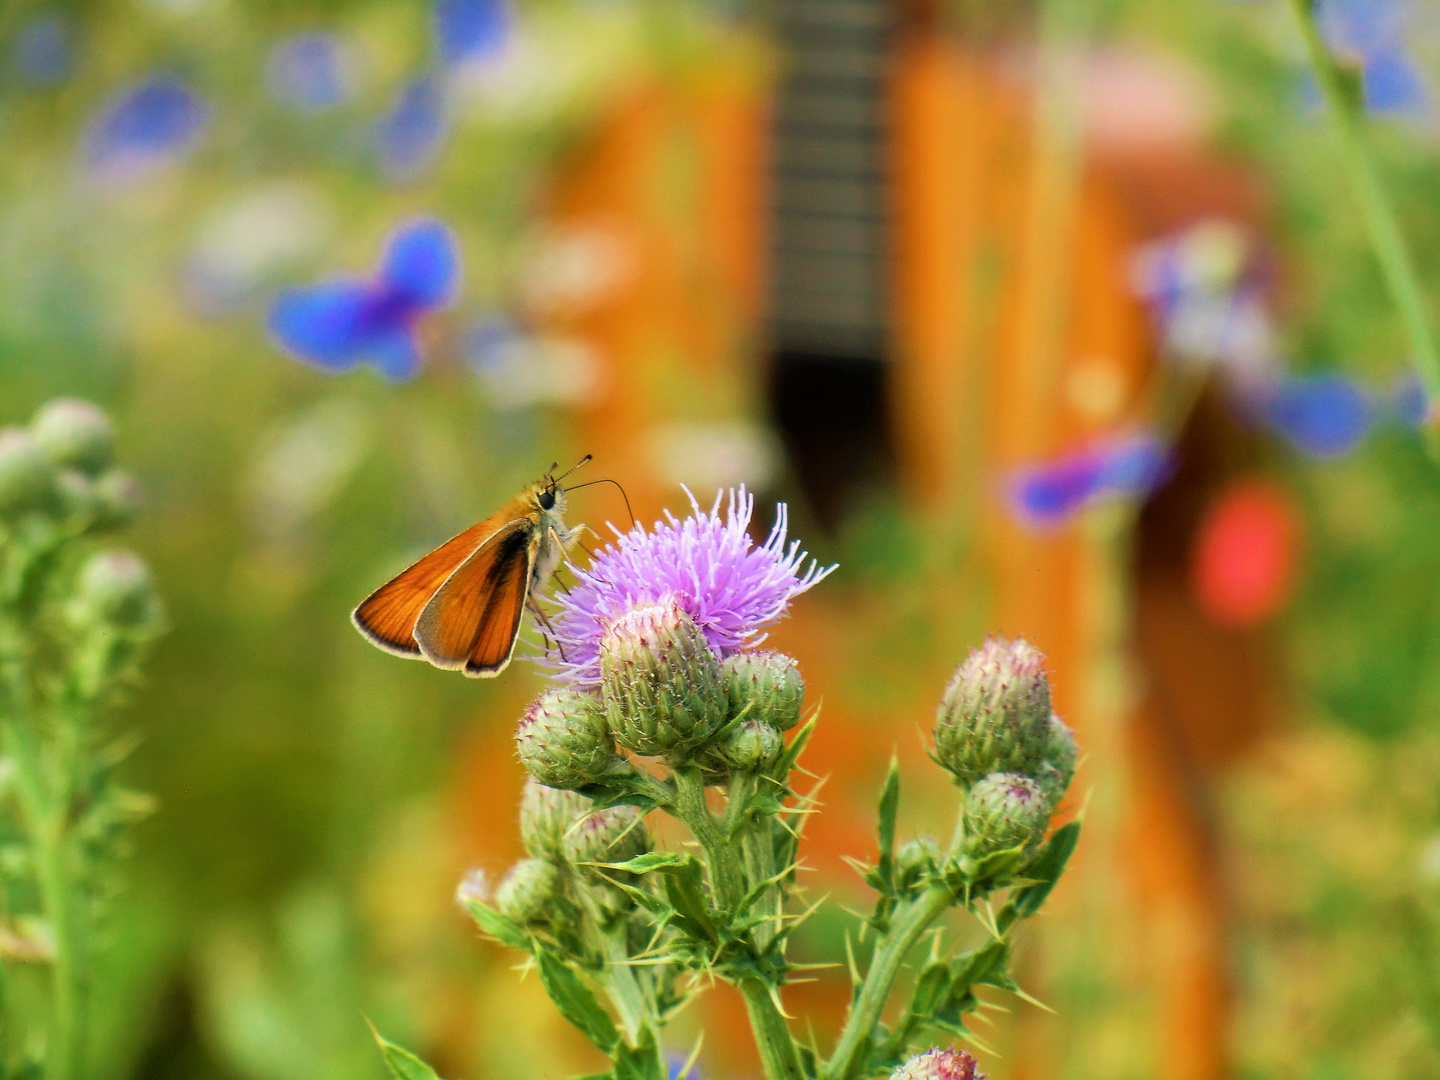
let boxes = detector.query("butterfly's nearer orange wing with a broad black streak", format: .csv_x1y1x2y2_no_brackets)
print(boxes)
415,518,540,678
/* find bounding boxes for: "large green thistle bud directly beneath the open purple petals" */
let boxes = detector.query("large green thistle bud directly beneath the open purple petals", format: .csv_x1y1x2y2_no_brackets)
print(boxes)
600,596,729,756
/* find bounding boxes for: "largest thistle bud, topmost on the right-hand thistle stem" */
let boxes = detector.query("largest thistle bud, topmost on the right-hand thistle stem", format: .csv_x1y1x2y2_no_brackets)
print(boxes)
935,638,1050,783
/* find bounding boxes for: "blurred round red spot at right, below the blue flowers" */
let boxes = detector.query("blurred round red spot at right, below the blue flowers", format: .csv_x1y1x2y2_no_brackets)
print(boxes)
1191,480,1300,629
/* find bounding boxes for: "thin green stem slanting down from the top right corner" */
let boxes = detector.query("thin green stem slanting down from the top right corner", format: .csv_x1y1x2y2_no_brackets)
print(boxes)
1290,0,1440,434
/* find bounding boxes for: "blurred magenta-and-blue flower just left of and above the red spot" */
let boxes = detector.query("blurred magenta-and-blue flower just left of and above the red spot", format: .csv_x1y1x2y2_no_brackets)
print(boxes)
1011,433,1172,527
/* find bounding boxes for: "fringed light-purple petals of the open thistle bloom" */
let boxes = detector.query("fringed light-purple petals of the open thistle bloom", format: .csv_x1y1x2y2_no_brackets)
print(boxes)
552,487,835,688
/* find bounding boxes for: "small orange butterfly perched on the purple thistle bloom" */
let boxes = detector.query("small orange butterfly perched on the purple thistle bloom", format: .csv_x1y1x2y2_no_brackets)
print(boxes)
351,454,590,678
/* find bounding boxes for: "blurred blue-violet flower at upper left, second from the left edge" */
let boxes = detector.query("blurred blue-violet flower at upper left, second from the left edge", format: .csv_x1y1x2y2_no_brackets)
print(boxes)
84,75,210,181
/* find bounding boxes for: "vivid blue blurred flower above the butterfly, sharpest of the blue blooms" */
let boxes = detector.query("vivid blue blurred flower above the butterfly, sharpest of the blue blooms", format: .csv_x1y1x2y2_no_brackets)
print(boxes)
269,217,459,379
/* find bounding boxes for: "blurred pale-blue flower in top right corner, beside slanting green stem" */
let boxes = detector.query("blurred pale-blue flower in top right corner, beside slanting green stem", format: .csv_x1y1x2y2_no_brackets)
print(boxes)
1312,0,1431,114
